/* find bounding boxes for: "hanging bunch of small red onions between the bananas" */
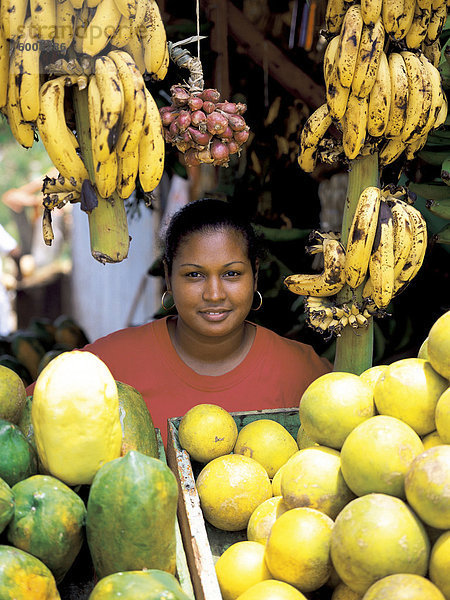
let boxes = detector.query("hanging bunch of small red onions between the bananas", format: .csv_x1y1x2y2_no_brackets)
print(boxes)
160,85,249,167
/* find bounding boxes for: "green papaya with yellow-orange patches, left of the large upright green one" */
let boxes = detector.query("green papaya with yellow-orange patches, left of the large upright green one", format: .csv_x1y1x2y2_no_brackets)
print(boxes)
6,475,86,583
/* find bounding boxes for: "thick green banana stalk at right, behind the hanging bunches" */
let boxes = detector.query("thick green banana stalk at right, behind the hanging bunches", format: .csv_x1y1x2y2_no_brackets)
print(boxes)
334,153,379,375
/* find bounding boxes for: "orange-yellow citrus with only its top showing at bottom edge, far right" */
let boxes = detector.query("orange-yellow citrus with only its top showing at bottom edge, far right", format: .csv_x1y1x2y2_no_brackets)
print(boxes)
363,573,445,600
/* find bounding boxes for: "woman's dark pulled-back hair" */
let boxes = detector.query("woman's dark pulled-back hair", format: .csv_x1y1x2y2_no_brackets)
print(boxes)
164,198,262,275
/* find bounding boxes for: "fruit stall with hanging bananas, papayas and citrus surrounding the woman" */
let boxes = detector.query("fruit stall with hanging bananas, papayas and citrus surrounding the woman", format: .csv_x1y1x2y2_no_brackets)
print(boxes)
0,0,450,600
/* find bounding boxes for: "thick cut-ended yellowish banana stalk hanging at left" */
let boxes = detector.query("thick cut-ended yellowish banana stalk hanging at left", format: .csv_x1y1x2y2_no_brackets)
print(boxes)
73,86,130,263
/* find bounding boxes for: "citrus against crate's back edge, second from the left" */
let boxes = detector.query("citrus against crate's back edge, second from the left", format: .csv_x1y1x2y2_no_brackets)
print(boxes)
234,419,298,478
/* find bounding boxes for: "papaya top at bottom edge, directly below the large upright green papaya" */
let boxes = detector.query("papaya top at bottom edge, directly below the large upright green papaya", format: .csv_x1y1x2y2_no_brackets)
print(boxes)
89,569,190,600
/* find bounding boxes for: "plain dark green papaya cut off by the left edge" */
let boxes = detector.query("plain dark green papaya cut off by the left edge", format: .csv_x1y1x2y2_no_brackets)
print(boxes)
0,419,37,488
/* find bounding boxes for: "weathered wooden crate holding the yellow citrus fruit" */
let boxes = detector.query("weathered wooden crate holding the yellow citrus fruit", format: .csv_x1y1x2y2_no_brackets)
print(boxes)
167,408,300,600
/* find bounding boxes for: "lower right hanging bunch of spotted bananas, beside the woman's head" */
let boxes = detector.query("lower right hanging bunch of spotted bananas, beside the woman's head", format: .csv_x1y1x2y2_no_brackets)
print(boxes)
284,186,427,334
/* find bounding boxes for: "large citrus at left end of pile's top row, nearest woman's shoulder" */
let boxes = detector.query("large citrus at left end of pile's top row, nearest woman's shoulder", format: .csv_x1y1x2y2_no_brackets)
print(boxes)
299,372,375,450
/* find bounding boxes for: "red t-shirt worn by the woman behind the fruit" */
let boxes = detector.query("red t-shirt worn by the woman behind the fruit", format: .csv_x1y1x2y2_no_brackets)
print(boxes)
78,317,331,443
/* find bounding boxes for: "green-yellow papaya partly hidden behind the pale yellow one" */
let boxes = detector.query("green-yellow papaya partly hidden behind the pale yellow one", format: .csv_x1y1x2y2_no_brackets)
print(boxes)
116,381,158,458
